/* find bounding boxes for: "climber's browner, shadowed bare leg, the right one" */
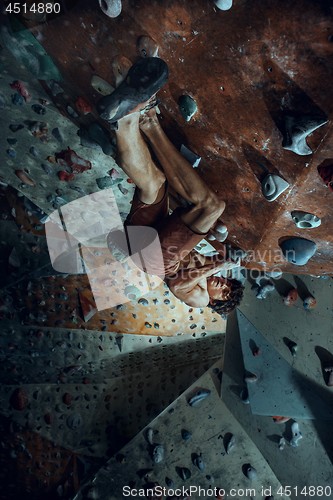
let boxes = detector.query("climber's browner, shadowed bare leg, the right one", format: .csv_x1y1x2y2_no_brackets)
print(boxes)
140,109,225,233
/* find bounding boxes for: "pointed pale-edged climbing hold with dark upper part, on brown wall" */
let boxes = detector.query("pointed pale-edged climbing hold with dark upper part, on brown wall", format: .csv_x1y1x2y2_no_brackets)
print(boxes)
282,114,328,156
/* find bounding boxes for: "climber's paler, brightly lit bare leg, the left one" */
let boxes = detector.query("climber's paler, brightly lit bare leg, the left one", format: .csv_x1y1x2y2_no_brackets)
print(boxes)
116,112,165,205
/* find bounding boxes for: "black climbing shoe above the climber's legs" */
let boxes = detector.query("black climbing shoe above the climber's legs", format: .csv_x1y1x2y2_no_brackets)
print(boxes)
97,57,169,123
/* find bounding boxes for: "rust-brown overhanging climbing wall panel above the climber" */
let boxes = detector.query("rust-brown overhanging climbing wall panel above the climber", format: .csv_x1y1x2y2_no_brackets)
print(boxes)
7,0,333,274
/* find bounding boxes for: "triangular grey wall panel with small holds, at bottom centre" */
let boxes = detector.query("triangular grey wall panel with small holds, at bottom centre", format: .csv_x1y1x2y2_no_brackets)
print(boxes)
75,363,289,500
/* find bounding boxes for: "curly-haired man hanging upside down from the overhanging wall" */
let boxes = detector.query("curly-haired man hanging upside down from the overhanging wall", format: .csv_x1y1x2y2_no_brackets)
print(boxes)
98,57,243,314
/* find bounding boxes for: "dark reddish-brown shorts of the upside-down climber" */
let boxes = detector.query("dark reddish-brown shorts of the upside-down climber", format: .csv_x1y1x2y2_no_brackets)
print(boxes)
125,184,207,277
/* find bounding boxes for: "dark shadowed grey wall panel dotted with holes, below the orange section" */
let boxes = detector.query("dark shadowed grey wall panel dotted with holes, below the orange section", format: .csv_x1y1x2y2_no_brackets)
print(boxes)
0,321,224,457
